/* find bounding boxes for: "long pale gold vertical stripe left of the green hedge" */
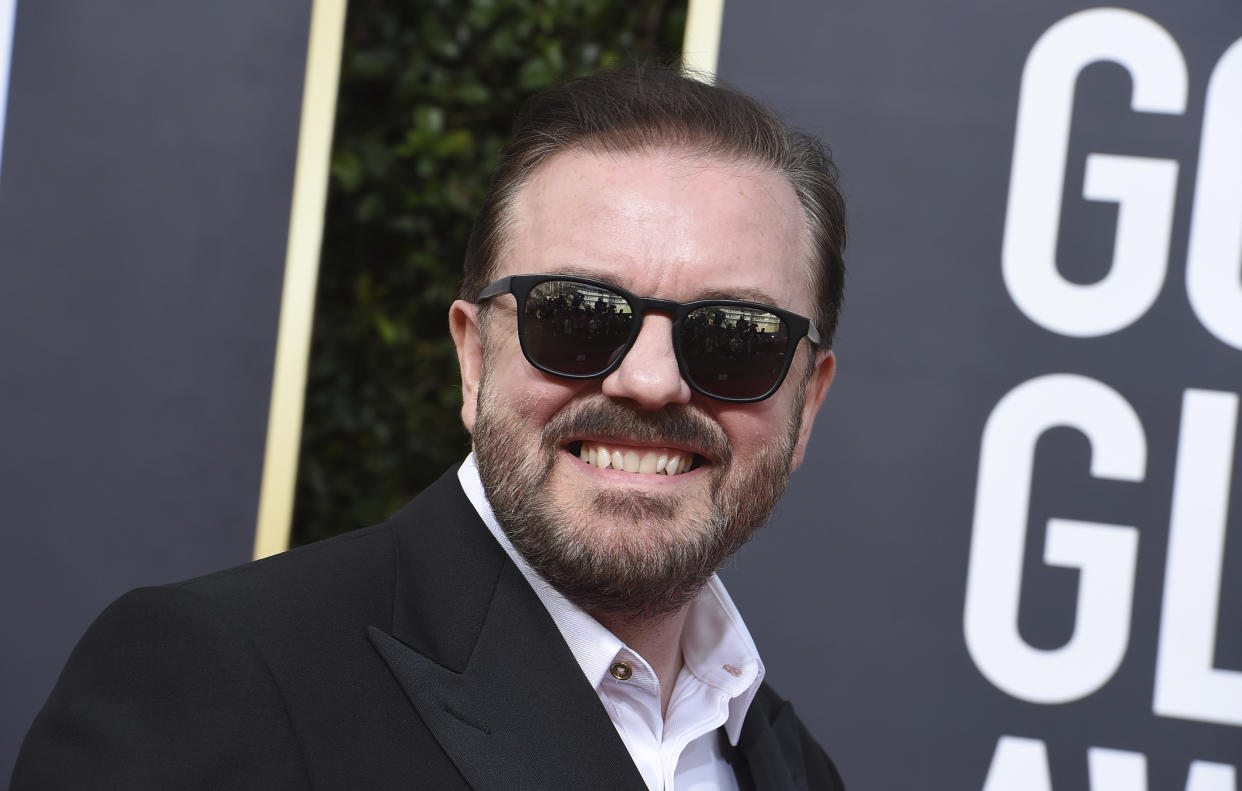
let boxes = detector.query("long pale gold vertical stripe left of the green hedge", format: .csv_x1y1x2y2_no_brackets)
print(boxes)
255,0,347,558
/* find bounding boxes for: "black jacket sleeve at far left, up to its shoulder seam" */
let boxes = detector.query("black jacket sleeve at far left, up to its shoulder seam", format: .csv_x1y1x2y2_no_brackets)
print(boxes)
12,587,306,790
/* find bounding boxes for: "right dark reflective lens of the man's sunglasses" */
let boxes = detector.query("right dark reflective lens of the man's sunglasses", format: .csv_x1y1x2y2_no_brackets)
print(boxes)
681,305,789,399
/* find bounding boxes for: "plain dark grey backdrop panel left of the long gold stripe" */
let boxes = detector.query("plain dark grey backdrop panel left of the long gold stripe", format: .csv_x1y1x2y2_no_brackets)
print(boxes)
0,0,311,781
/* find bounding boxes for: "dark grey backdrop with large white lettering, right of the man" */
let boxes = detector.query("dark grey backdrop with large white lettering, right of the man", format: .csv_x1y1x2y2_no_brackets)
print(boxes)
719,0,1242,791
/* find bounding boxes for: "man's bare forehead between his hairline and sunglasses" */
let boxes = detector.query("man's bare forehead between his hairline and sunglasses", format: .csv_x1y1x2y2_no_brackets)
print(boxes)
498,150,811,314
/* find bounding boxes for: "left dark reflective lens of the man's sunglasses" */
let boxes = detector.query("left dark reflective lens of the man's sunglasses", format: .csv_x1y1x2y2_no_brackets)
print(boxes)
523,281,633,376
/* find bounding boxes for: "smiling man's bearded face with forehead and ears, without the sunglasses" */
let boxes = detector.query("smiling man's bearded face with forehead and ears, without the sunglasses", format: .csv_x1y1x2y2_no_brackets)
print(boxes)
450,151,833,615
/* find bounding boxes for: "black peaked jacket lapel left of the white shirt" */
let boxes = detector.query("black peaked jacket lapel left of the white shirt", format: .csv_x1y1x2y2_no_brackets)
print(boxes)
368,473,646,791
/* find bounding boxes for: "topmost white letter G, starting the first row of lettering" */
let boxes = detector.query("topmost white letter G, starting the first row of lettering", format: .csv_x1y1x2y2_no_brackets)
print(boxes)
1001,9,1187,338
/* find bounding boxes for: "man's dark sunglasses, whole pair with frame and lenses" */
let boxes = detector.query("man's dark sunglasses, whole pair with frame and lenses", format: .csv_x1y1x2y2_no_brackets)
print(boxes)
478,274,820,402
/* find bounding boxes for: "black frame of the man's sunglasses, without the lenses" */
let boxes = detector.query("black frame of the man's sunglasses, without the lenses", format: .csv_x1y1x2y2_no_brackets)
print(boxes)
474,274,820,404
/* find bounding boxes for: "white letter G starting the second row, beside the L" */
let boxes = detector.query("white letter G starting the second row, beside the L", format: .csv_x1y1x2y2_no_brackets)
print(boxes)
964,374,1148,703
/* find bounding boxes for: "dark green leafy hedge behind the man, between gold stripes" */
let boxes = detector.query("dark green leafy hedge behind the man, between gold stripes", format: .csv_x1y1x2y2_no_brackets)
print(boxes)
293,0,686,545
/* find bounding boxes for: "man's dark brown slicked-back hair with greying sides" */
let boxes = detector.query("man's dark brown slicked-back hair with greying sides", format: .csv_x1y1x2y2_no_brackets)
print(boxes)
461,66,846,348
